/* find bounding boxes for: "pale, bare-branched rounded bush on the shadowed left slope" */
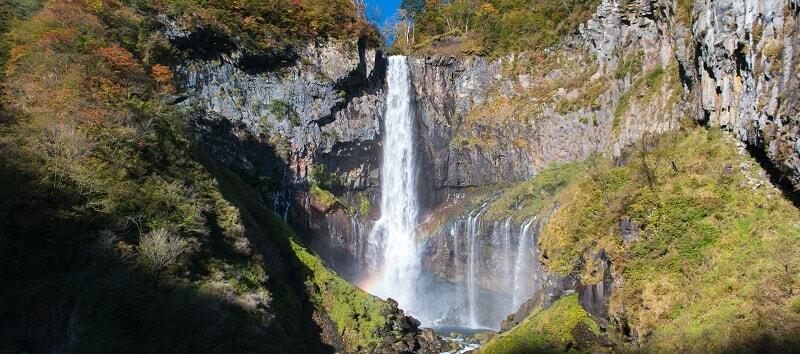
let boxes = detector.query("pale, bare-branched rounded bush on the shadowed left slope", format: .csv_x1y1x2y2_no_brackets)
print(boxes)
136,229,189,286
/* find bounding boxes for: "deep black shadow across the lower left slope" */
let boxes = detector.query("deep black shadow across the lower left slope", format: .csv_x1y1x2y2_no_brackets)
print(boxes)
0,145,334,353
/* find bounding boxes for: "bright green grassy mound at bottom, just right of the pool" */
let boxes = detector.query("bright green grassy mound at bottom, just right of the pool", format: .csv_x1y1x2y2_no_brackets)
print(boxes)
477,295,599,354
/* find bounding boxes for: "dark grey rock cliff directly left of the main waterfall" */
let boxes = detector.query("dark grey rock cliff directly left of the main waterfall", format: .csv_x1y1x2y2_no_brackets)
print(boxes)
168,30,385,275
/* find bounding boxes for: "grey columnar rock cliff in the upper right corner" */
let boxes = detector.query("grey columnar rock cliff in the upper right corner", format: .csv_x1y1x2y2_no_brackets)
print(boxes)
692,1,800,190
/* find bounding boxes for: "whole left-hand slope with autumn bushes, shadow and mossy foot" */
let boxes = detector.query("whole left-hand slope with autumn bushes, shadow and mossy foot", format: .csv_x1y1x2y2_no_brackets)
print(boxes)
0,2,385,352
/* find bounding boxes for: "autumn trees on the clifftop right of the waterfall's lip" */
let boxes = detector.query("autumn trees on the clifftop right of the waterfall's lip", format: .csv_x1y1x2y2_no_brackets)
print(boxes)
393,0,599,56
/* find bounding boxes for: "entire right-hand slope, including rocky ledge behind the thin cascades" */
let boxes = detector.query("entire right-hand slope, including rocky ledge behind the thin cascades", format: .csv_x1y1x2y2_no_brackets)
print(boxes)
422,127,800,353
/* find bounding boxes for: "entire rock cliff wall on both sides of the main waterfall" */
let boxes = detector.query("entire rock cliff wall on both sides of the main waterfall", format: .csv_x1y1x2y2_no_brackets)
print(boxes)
172,0,800,296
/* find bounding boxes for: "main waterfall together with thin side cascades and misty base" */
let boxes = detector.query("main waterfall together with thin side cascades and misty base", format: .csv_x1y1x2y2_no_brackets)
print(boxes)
353,56,542,332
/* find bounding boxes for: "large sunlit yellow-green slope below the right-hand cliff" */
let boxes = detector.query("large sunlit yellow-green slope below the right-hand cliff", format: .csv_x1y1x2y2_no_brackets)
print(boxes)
540,129,800,351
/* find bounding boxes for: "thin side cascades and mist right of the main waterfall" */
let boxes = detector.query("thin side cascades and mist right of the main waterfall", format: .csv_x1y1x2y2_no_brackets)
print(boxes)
428,203,547,328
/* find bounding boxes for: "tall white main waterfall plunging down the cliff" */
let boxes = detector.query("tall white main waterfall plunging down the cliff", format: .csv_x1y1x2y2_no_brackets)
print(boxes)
368,56,420,312
